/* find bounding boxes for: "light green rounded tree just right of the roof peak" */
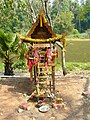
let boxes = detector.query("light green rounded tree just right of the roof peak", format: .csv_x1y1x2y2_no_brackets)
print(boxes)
51,0,74,33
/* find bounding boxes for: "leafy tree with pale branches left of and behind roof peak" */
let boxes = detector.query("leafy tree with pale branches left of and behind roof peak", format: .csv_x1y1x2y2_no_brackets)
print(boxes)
0,0,53,34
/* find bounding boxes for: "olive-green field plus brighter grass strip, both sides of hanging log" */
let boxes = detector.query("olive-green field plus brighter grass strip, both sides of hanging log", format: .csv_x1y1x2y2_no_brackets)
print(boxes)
56,38,90,71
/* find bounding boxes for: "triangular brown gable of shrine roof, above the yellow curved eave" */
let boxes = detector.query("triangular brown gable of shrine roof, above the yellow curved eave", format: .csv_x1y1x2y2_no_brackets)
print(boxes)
26,13,56,39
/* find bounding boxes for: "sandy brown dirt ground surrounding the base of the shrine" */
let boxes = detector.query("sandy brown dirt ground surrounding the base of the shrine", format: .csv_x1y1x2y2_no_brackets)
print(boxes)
0,72,90,120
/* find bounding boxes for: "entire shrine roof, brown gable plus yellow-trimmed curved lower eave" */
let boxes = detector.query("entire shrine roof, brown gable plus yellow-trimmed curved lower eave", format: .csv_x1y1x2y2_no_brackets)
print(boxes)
18,10,65,47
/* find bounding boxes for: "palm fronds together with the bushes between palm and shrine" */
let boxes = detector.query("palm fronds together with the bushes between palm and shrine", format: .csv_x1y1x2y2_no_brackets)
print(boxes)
0,30,26,72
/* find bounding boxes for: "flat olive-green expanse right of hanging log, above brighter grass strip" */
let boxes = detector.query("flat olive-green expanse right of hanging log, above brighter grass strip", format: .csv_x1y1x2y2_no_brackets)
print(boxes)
66,40,90,62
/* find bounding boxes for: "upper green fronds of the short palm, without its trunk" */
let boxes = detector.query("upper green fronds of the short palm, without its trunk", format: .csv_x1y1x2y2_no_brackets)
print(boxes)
0,29,18,52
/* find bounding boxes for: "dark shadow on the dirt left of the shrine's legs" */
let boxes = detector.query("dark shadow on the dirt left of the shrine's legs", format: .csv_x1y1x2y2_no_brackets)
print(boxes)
0,77,34,95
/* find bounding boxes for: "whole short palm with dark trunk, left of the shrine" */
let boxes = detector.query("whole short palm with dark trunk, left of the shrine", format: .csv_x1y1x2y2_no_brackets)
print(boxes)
0,30,18,75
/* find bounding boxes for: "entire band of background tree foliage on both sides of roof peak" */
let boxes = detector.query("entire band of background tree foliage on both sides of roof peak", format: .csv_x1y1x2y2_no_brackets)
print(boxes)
0,0,90,34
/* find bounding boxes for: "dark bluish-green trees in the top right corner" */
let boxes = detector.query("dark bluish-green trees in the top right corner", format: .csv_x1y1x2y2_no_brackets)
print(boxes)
70,0,90,33
